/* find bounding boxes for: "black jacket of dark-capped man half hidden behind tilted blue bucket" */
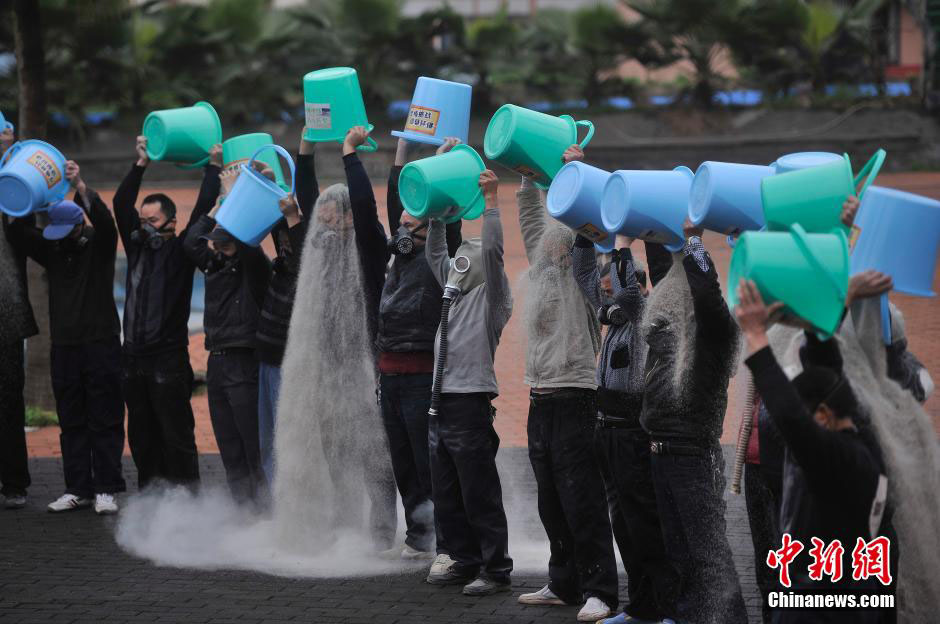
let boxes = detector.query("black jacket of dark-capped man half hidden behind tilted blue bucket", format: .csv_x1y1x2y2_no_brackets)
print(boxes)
183,215,271,351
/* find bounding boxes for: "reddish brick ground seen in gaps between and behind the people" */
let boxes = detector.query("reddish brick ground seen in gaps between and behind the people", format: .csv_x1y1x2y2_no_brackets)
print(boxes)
22,170,940,457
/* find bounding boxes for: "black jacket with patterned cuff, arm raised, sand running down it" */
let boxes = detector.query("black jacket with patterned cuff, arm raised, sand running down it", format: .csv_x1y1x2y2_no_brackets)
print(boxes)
640,253,737,443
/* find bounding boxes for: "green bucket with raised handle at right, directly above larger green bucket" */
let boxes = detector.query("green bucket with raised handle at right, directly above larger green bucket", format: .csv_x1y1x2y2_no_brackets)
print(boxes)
761,149,886,234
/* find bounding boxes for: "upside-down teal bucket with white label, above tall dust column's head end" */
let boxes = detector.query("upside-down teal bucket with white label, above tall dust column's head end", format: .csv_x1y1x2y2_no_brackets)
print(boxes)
304,67,378,152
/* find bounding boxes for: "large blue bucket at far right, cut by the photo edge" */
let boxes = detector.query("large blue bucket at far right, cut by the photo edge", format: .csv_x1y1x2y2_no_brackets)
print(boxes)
850,186,940,297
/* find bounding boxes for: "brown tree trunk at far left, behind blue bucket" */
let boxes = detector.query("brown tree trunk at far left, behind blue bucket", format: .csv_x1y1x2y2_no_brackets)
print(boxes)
13,0,55,410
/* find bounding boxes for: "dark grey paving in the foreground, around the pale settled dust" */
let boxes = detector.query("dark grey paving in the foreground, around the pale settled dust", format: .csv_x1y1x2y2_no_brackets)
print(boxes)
0,448,760,624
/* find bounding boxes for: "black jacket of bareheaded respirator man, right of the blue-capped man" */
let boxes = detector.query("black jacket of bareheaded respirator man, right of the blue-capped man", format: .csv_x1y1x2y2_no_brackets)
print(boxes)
114,164,220,355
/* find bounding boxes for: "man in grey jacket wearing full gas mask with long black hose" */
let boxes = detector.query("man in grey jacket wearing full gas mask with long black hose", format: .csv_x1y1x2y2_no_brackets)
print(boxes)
425,170,512,596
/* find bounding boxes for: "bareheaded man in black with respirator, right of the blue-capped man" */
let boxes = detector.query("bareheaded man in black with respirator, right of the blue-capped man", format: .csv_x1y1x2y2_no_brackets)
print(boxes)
114,136,222,489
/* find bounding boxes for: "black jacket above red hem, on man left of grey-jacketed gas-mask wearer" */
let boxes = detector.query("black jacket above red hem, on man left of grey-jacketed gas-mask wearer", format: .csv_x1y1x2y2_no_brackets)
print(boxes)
375,167,461,353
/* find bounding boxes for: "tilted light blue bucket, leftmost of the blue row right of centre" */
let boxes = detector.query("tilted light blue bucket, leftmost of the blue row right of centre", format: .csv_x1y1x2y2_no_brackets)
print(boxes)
546,160,614,251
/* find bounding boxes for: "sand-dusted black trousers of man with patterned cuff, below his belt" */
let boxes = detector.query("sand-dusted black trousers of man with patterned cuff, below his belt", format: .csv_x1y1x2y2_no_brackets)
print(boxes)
651,441,747,624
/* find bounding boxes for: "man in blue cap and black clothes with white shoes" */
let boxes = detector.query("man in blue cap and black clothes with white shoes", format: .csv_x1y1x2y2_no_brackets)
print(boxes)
10,160,126,515
